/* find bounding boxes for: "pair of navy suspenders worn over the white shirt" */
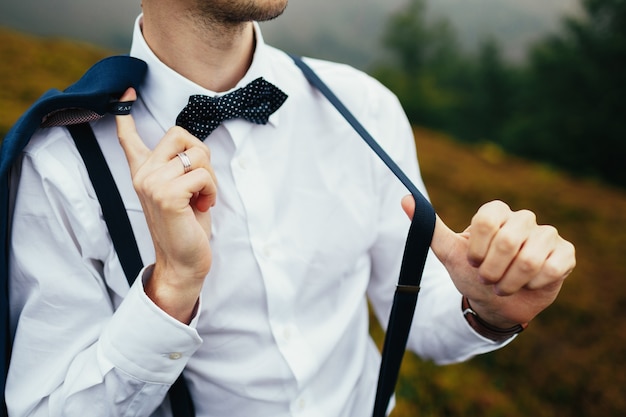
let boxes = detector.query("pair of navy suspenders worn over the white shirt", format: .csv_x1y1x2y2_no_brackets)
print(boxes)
68,56,435,417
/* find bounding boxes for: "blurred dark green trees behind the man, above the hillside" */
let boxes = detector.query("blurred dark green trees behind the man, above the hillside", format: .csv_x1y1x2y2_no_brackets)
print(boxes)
373,0,626,186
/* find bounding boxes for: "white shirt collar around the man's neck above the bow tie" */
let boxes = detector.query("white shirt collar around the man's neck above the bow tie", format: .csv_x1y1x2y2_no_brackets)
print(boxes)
130,15,280,131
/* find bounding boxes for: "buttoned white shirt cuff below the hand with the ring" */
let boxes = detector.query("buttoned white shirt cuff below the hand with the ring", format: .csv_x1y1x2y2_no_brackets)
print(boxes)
99,267,202,384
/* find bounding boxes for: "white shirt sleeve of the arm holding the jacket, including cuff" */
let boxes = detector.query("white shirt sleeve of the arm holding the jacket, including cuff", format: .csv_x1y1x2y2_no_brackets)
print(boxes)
6,129,202,417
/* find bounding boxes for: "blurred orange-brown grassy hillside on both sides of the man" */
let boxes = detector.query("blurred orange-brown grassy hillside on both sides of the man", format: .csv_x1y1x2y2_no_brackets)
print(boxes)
0,30,626,417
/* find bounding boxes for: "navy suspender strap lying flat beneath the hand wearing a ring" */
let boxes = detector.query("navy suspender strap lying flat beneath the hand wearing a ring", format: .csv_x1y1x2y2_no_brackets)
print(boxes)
67,123,195,417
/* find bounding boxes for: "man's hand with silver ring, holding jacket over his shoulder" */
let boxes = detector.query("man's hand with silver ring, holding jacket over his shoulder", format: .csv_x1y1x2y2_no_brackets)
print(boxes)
116,88,217,323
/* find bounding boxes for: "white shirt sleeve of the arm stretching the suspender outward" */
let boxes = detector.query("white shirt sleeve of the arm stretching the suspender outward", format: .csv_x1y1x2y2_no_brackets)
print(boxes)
363,79,506,364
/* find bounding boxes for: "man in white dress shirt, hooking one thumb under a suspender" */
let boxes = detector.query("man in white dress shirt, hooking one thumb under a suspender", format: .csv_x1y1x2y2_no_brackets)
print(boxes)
7,0,575,417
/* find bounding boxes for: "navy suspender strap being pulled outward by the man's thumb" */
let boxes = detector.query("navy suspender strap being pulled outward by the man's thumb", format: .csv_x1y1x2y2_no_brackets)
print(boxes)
291,55,435,417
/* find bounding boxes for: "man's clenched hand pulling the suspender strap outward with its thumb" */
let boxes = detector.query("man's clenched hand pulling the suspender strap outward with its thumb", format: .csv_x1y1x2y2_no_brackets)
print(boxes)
402,196,576,329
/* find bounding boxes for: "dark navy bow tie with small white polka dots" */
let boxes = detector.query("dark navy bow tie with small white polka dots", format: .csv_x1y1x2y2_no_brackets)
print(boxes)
176,78,287,140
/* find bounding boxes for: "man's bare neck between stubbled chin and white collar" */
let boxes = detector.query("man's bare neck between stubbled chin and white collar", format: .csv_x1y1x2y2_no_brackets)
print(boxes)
142,2,255,92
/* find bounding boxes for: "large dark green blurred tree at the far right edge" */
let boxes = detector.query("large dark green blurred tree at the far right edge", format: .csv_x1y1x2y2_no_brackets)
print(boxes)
505,0,626,186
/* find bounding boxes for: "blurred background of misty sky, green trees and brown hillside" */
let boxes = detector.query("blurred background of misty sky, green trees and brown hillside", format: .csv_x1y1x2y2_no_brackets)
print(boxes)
0,0,626,417
